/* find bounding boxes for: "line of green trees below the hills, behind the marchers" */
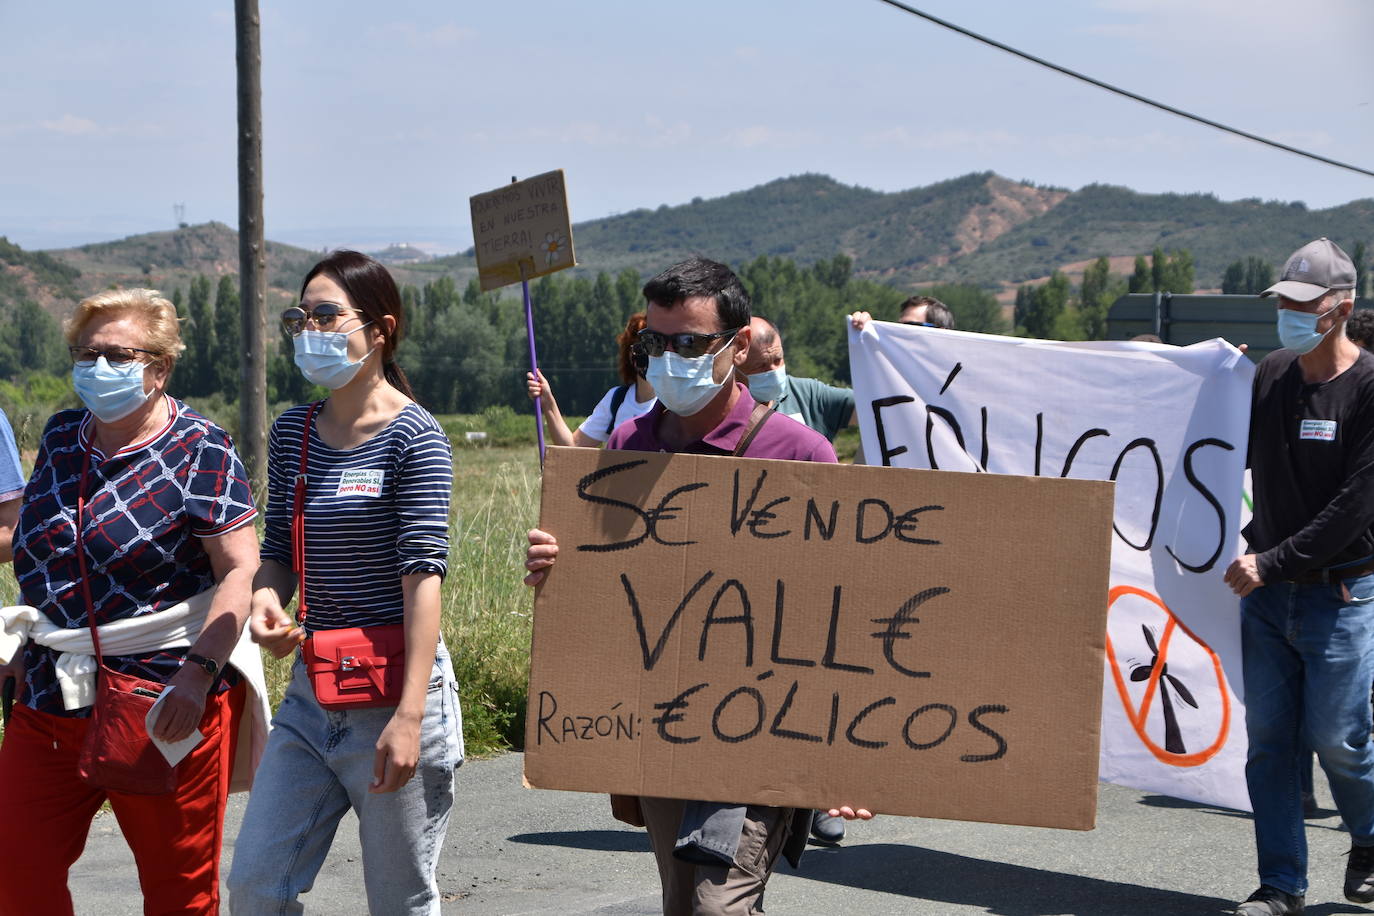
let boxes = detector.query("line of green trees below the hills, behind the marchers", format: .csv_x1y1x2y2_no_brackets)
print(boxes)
8,244,1367,431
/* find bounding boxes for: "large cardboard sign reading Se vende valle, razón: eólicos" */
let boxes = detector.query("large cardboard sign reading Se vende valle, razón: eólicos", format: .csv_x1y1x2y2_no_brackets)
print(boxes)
525,448,1112,829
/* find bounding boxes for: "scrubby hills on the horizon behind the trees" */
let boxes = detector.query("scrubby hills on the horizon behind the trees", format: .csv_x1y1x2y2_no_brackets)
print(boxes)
0,172,1374,313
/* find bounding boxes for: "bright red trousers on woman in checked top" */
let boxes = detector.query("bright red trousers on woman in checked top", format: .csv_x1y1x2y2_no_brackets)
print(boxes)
0,684,245,916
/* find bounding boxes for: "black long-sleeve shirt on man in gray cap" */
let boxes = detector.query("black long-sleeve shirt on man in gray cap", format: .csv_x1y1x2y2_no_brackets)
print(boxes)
1245,350,1374,582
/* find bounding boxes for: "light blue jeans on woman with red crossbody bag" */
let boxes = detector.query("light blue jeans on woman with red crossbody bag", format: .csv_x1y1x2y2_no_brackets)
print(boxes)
228,644,463,916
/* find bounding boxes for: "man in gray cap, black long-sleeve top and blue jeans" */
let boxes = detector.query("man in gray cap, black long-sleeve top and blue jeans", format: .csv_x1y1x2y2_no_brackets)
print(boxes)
1226,239,1374,916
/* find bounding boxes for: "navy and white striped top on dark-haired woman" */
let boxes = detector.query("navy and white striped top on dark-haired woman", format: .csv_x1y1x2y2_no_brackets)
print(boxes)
262,404,453,630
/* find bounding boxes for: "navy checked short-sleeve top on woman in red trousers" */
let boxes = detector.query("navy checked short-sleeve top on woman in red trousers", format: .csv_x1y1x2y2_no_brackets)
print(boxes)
14,397,257,715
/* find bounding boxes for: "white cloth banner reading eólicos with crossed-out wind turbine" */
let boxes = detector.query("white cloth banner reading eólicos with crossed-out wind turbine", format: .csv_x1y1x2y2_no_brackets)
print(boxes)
849,321,1254,810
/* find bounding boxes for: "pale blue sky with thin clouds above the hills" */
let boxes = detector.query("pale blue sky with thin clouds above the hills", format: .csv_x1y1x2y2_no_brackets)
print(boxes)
0,0,1374,251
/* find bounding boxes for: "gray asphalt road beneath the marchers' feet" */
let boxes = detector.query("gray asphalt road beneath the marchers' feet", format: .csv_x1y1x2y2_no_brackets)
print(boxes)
71,754,1374,916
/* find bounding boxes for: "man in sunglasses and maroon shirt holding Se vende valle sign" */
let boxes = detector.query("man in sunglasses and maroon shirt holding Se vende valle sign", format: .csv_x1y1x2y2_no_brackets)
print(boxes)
525,258,871,915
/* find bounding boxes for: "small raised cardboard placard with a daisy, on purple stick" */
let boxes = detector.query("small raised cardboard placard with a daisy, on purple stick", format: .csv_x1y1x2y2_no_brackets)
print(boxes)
469,169,577,290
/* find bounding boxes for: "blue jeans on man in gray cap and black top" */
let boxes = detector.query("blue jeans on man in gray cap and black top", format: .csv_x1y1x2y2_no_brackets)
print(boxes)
1241,575,1374,894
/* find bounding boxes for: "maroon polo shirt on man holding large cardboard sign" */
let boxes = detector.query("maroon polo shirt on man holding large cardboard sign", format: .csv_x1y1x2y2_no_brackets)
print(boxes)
606,382,837,464
